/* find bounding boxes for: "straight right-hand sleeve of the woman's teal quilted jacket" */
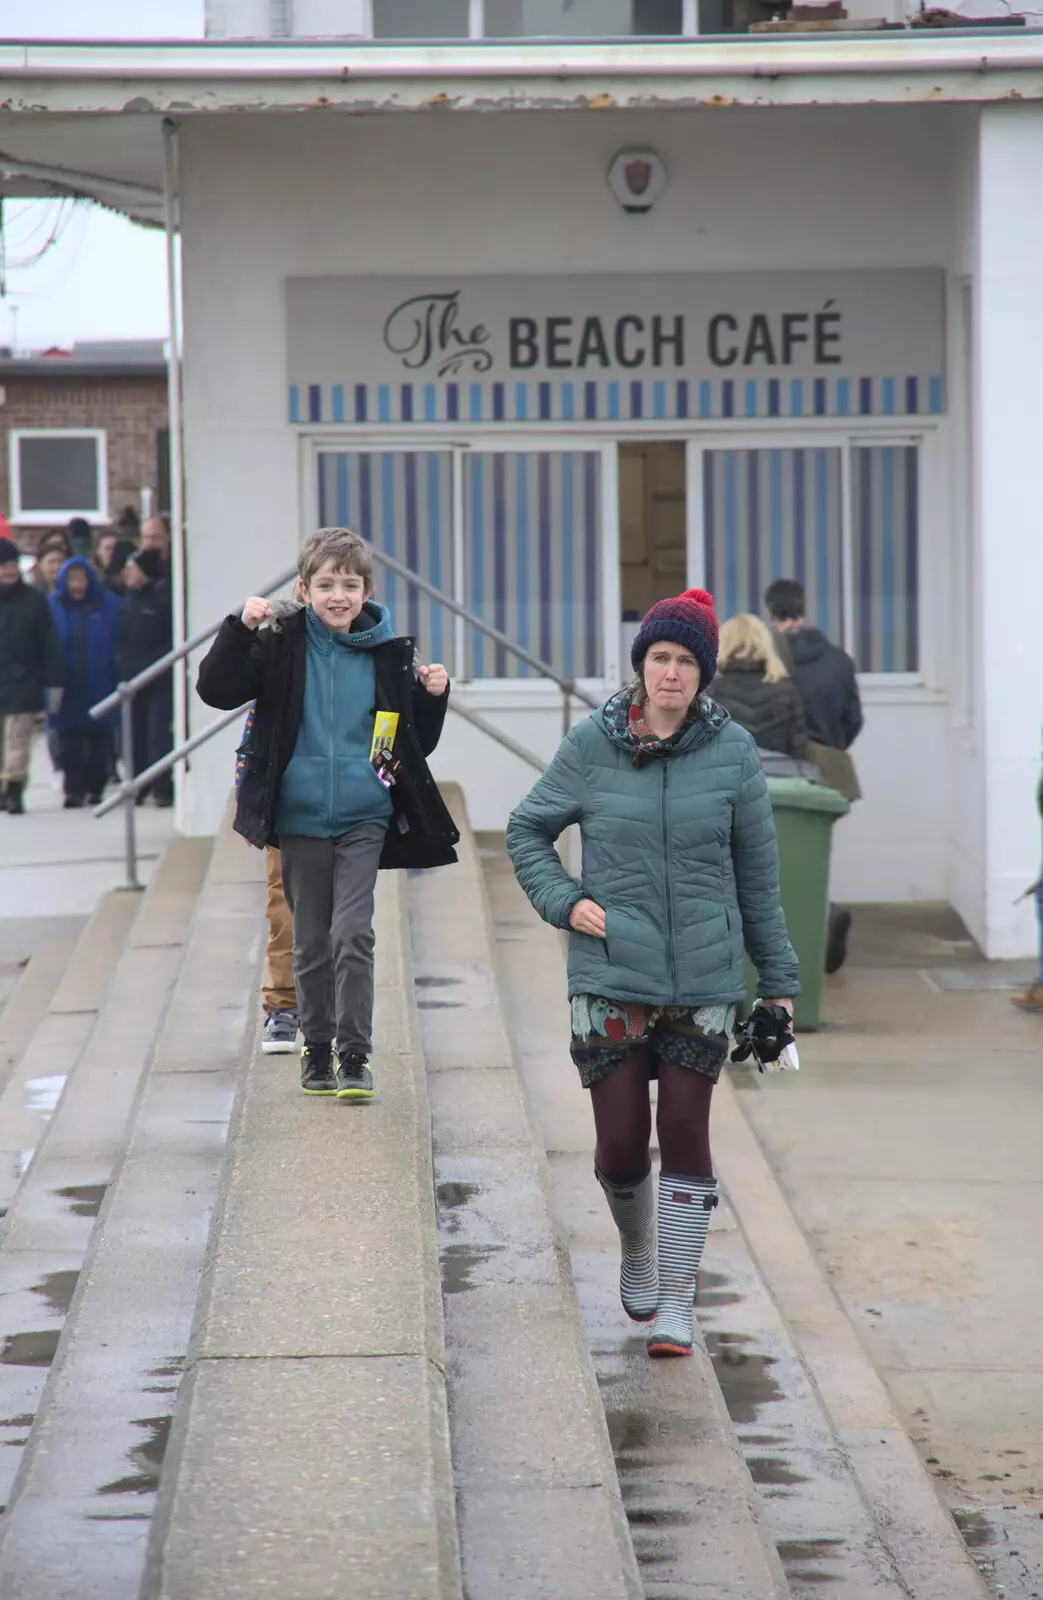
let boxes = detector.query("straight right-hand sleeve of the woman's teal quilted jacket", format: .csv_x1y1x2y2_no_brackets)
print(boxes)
731,746,800,1000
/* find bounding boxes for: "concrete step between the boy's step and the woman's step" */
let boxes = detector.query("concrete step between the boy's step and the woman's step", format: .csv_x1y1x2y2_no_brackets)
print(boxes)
410,787,643,1600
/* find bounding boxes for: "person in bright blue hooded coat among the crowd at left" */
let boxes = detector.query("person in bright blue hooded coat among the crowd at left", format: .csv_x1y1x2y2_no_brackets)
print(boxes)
50,555,122,810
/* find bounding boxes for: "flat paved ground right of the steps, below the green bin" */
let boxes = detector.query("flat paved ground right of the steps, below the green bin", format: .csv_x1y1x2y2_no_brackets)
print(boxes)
733,907,1043,1600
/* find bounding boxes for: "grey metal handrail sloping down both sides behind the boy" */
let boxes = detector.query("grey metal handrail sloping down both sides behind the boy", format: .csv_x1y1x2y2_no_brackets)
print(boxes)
90,549,601,890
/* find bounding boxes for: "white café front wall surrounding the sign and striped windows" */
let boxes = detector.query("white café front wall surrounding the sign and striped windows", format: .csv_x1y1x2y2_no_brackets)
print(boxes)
182,107,965,921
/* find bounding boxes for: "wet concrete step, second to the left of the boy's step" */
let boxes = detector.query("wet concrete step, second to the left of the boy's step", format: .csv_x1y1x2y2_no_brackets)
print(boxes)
0,840,210,1523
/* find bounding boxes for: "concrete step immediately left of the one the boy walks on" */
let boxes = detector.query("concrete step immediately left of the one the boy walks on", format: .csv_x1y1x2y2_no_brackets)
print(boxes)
0,829,264,1600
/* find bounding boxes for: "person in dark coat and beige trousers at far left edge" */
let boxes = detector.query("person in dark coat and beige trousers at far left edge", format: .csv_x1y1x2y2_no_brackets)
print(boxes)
0,538,64,816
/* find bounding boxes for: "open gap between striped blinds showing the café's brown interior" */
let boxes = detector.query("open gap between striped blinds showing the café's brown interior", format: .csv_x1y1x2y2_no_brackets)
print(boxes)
619,438,688,659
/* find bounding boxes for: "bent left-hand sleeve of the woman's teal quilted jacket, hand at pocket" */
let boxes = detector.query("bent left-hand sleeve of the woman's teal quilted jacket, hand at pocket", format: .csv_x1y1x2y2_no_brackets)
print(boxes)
507,736,585,928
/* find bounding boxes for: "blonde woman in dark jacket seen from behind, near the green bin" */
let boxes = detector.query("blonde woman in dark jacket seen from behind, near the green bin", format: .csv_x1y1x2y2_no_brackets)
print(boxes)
713,611,808,762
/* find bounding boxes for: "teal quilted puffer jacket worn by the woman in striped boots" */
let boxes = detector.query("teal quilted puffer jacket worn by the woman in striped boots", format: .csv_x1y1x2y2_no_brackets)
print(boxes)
507,691,800,1006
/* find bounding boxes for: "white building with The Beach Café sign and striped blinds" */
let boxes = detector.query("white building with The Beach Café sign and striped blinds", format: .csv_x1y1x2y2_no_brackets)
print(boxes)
0,8,1043,957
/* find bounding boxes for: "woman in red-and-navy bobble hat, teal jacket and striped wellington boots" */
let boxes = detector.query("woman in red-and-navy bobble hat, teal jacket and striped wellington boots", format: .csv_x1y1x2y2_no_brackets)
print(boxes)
507,589,797,1355
